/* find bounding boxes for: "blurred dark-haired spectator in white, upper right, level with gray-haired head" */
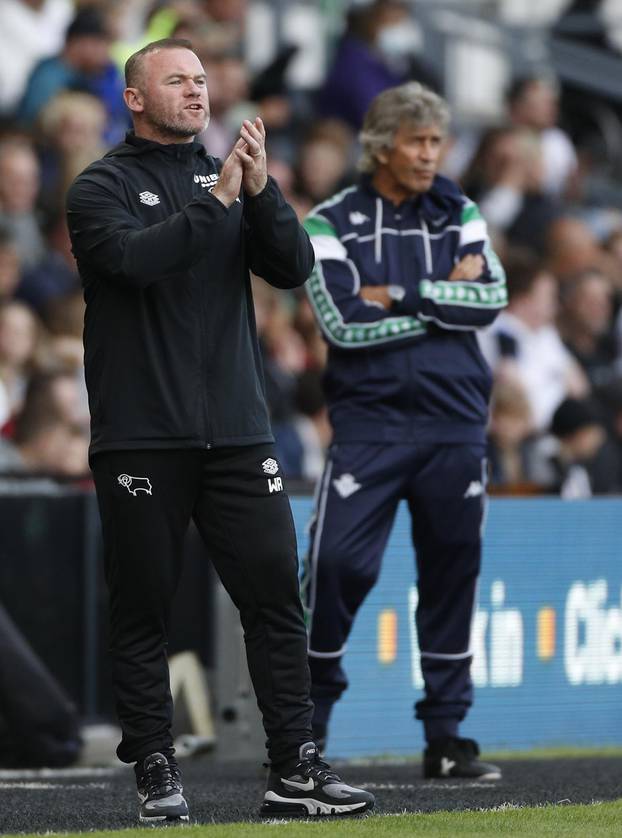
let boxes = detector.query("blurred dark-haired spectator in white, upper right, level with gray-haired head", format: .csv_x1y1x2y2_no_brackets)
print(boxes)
507,76,577,196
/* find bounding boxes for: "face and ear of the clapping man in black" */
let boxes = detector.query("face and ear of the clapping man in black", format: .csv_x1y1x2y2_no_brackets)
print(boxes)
126,49,209,142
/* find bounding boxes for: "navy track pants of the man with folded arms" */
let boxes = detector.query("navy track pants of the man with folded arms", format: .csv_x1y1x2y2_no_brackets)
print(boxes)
303,443,485,739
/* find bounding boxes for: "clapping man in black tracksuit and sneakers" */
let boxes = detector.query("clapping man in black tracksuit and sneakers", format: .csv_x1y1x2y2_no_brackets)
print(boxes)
67,39,373,823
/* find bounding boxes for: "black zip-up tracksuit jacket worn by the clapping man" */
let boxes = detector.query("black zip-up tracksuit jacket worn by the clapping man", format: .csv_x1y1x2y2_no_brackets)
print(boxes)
67,133,314,455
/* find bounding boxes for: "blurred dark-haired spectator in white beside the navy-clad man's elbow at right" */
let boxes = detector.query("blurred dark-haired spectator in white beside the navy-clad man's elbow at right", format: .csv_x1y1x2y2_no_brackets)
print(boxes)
478,251,589,432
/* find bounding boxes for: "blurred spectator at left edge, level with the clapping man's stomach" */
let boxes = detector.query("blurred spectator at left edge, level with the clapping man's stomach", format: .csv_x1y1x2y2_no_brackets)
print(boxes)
0,301,42,415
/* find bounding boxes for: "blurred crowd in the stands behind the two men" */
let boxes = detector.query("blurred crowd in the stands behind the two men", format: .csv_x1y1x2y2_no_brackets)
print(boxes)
0,0,622,498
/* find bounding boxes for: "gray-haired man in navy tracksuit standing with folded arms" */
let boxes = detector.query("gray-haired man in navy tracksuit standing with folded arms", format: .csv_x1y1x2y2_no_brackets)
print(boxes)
303,82,506,779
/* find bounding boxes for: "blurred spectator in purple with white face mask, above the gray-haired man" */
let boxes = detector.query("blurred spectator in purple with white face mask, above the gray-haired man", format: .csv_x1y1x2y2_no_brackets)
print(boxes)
318,0,440,131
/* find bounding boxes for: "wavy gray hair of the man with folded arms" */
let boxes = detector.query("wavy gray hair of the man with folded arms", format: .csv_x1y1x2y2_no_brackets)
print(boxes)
358,81,449,173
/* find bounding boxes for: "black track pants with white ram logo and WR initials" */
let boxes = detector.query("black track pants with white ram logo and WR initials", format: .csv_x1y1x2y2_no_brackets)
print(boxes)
92,444,313,763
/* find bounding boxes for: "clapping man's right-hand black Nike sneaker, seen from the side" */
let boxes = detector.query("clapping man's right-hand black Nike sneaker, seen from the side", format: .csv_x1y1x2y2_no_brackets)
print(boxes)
260,742,375,818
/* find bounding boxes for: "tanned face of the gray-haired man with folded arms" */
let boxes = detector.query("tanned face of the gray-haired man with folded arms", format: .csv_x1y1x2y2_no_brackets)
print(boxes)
374,122,444,200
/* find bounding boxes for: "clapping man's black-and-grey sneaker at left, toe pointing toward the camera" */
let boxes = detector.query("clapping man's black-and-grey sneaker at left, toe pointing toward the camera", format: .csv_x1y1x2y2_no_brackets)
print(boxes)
135,754,188,826
